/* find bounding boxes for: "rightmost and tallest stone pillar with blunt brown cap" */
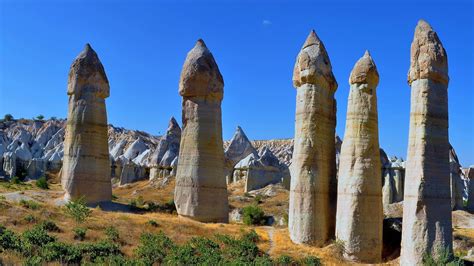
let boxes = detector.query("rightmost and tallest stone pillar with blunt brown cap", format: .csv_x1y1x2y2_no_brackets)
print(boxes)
400,20,453,265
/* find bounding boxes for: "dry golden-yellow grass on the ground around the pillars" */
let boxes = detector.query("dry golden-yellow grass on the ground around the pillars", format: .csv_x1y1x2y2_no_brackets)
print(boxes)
0,177,474,265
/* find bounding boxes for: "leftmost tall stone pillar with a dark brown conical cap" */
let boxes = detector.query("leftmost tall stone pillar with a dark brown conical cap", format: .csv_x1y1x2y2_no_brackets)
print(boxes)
61,44,112,203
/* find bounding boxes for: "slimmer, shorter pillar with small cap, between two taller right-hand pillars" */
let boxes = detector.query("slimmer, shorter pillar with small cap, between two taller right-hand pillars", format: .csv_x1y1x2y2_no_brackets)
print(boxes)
336,51,383,263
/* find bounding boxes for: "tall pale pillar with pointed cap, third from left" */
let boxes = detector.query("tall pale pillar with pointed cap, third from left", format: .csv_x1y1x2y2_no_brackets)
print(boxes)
288,31,337,246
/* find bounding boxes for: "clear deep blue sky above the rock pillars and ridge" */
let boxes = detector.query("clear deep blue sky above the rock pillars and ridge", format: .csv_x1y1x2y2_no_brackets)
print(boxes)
0,0,474,165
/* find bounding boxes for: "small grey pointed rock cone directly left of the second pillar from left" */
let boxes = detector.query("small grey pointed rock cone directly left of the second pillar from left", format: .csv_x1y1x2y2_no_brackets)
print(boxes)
149,117,181,179
